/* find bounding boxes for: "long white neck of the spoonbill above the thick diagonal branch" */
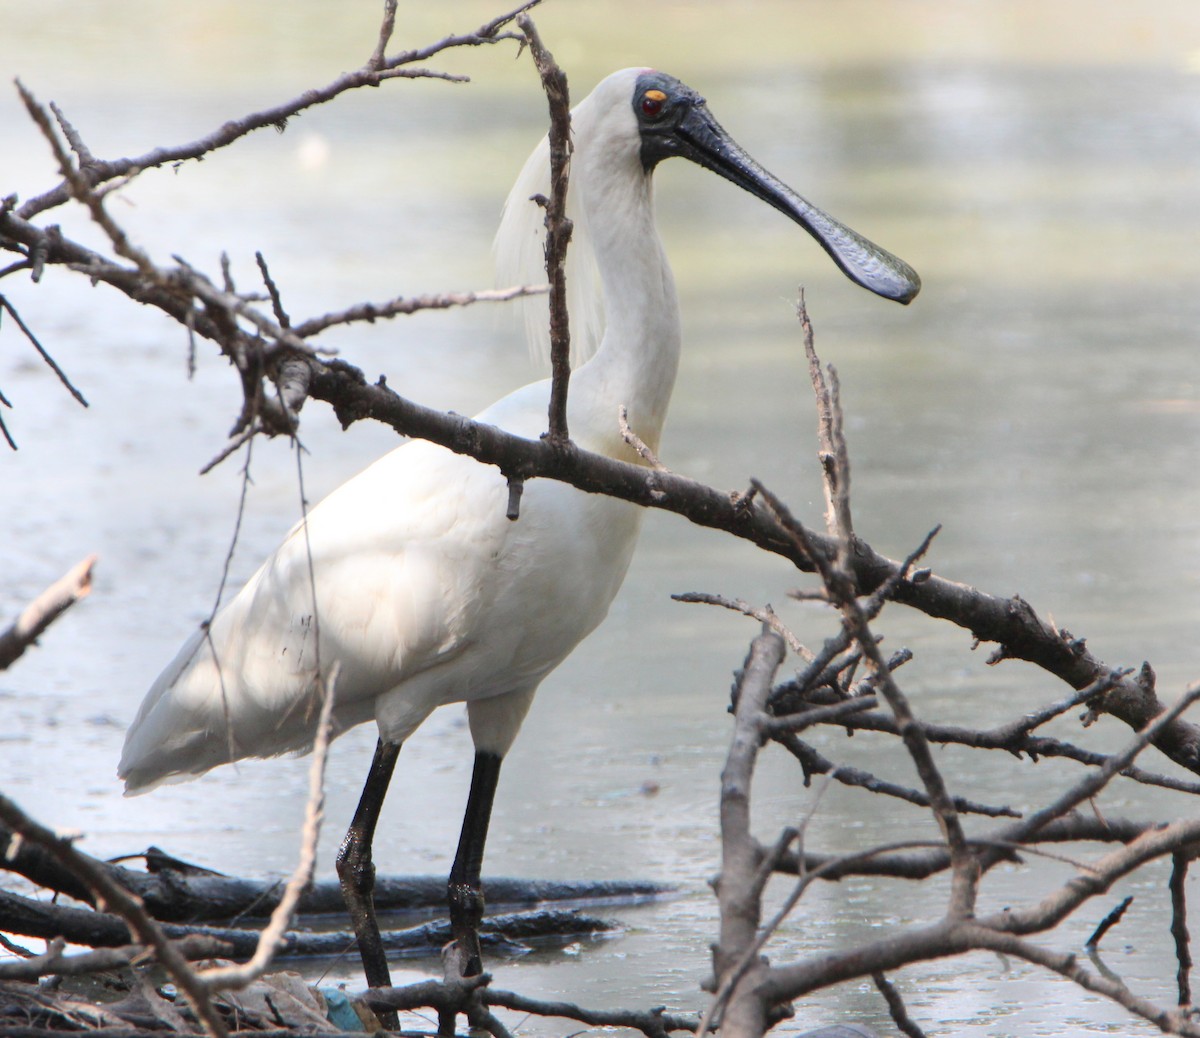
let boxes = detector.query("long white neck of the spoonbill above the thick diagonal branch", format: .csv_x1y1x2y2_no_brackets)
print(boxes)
571,168,680,457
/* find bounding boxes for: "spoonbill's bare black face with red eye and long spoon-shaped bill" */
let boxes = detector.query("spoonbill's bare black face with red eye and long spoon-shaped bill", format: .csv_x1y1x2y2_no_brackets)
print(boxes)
632,72,920,302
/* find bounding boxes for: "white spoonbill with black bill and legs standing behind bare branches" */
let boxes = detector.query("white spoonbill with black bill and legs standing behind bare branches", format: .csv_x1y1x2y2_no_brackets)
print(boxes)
119,68,920,986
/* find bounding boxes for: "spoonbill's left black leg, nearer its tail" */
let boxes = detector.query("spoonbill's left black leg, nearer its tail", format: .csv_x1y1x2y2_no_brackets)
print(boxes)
337,739,400,993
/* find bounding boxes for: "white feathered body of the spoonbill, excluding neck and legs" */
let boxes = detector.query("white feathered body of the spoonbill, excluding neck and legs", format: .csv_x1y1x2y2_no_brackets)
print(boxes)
118,383,640,792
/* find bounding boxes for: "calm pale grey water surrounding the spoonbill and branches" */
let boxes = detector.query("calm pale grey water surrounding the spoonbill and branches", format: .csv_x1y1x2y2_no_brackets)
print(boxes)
0,0,1200,1036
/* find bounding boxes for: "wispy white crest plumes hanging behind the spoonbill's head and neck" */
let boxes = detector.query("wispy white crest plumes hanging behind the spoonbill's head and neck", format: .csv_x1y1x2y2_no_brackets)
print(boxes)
492,126,605,367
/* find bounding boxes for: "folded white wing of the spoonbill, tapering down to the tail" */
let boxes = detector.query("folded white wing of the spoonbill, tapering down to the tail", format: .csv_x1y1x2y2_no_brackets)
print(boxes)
119,442,508,791
